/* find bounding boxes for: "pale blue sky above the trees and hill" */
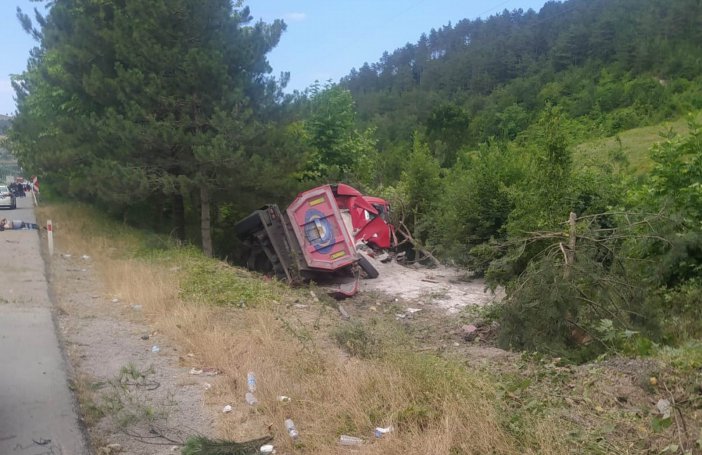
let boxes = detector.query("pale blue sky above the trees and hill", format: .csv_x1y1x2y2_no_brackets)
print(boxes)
0,0,546,115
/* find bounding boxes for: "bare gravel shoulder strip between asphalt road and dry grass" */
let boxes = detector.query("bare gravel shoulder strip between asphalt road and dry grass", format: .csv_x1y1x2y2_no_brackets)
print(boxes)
50,252,218,455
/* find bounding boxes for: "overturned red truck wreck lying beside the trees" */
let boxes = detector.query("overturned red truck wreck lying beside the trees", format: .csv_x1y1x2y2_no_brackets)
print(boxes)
235,183,395,296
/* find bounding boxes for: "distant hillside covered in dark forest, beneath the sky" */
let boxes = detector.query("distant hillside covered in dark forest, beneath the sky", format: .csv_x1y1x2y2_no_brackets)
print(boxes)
342,0,702,173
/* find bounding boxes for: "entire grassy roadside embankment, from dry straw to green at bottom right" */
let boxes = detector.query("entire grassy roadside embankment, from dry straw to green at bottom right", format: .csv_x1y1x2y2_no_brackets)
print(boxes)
39,204,700,455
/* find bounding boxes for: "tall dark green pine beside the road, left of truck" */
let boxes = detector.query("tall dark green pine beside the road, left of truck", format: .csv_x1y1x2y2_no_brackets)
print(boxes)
13,0,285,254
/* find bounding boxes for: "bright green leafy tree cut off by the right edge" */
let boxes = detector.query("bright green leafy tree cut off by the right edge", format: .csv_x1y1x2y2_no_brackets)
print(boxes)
628,117,702,343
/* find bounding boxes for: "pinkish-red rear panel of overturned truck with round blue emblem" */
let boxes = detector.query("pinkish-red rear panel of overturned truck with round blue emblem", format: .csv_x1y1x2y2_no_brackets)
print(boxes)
287,185,358,271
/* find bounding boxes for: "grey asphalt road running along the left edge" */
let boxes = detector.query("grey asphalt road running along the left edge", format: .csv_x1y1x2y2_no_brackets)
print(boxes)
0,195,89,455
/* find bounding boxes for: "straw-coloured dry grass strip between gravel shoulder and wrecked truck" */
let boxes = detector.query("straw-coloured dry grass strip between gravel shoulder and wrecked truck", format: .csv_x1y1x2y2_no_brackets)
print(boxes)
39,205,568,455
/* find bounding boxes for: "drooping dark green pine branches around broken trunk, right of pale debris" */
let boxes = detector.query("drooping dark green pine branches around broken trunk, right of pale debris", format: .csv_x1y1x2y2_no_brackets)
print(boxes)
499,216,659,362
